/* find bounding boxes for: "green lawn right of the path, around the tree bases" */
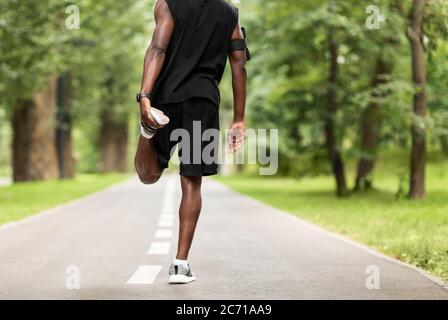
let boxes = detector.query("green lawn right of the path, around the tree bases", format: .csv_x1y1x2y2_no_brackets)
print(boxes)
218,155,448,280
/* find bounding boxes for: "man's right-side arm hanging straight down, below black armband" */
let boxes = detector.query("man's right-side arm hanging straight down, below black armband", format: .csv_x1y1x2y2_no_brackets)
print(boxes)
229,23,247,152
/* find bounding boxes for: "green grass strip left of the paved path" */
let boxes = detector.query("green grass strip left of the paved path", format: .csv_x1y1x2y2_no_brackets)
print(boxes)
0,173,128,225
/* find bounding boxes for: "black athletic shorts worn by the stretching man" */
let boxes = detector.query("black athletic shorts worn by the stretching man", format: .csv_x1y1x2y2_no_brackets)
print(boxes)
153,98,219,176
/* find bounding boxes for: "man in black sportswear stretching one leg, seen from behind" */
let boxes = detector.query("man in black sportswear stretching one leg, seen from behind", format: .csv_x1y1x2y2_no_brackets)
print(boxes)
135,0,248,283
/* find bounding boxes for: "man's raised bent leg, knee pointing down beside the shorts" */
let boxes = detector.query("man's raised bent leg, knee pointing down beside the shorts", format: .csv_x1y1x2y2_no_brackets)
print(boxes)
134,136,163,184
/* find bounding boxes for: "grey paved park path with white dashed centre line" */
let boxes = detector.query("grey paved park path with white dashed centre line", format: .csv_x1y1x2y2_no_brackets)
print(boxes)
0,175,448,299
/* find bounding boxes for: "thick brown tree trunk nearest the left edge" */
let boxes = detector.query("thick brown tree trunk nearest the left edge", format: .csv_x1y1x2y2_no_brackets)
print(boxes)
12,78,58,182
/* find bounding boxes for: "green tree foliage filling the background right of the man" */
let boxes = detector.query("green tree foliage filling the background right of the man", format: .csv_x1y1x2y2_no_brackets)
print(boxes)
243,0,448,188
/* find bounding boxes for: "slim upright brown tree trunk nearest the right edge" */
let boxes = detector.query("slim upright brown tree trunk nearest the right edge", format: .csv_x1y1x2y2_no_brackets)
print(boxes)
407,0,427,198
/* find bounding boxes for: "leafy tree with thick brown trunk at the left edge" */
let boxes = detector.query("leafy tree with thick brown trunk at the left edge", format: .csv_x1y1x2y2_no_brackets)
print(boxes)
0,0,64,181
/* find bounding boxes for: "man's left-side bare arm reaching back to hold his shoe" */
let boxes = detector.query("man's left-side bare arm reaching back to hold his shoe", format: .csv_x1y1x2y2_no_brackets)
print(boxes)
140,0,174,128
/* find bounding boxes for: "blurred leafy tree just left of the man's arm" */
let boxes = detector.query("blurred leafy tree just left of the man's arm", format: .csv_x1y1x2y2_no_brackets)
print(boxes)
64,0,147,172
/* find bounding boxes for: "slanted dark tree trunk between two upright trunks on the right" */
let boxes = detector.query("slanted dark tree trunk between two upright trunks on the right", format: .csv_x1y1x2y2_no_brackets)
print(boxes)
354,57,391,190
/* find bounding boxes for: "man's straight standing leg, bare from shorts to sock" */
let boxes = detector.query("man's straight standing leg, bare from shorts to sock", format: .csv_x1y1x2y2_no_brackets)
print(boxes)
176,176,202,260
